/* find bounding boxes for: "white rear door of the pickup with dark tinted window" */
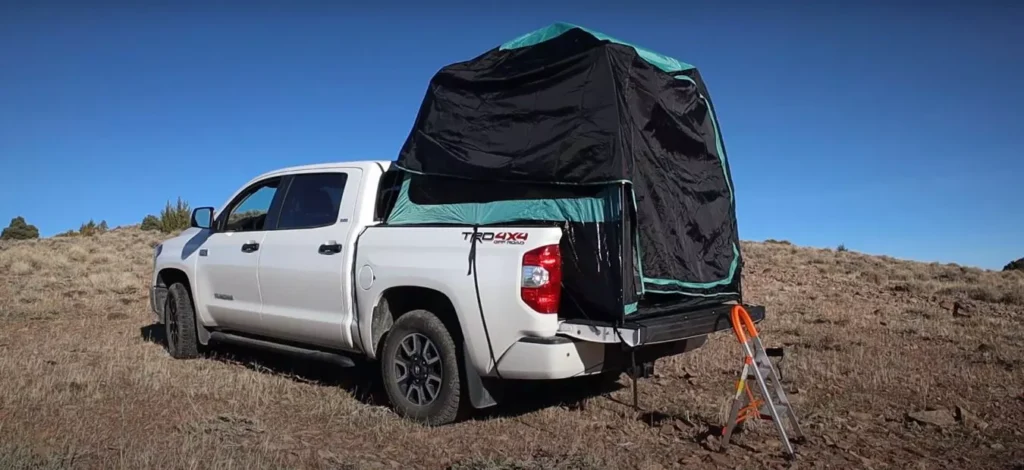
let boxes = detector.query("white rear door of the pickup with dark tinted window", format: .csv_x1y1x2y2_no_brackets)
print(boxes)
253,168,361,349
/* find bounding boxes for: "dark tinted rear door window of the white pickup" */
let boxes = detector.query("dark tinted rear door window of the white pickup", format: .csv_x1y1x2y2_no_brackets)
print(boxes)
278,173,348,230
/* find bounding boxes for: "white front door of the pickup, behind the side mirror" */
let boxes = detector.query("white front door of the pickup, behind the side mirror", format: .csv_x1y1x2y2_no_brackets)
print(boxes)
196,177,282,332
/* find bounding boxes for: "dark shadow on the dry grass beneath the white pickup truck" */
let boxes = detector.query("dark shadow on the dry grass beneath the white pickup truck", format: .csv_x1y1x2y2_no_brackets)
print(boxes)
139,324,622,420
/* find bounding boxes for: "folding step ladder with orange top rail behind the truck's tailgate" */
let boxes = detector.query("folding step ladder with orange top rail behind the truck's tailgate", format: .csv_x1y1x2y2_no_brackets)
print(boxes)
722,305,804,458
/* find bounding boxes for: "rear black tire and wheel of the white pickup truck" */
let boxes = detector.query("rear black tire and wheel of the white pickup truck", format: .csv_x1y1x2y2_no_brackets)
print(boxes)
380,310,468,426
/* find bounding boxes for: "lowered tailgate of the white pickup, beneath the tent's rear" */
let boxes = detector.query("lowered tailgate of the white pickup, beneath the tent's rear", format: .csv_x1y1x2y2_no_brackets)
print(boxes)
558,304,765,347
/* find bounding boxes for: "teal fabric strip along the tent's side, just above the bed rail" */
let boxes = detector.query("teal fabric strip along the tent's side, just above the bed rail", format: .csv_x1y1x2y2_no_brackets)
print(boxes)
387,176,622,225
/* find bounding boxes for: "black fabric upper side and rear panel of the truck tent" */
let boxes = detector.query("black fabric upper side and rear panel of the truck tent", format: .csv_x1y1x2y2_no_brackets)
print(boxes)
395,24,742,321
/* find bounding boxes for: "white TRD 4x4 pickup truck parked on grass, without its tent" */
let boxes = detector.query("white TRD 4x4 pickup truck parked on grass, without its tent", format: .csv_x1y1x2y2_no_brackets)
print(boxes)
151,161,764,424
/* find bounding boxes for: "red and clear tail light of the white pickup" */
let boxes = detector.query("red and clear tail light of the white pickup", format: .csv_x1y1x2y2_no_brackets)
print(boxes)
520,245,562,313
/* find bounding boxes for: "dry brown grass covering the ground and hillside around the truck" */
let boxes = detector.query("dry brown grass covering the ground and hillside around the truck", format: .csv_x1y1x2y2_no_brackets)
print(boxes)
0,229,1024,469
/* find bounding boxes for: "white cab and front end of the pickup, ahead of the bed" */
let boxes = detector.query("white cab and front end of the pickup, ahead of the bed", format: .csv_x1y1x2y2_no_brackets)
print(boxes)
154,162,387,351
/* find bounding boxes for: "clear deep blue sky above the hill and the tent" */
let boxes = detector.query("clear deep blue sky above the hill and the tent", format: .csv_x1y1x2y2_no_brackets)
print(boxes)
0,1,1024,268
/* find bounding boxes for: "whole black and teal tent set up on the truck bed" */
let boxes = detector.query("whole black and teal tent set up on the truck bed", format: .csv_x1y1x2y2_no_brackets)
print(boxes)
387,23,742,322
